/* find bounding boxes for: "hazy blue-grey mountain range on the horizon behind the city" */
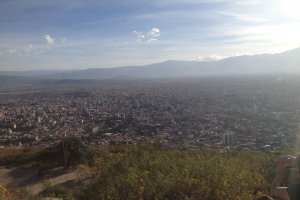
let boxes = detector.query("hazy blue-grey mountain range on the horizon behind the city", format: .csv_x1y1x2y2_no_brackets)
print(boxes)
0,48,300,79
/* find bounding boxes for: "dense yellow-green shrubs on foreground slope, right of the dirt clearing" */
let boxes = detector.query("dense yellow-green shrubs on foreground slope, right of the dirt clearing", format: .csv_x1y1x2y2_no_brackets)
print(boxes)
77,145,271,200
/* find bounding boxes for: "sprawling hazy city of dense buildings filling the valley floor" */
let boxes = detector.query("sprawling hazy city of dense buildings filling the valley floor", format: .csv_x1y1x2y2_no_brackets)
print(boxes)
0,76,300,152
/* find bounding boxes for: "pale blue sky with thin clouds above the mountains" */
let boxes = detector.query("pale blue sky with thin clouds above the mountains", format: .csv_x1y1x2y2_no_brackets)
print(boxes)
0,0,300,71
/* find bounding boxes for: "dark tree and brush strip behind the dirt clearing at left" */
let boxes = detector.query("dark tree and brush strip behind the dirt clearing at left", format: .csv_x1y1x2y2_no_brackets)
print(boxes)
0,138,94,170
